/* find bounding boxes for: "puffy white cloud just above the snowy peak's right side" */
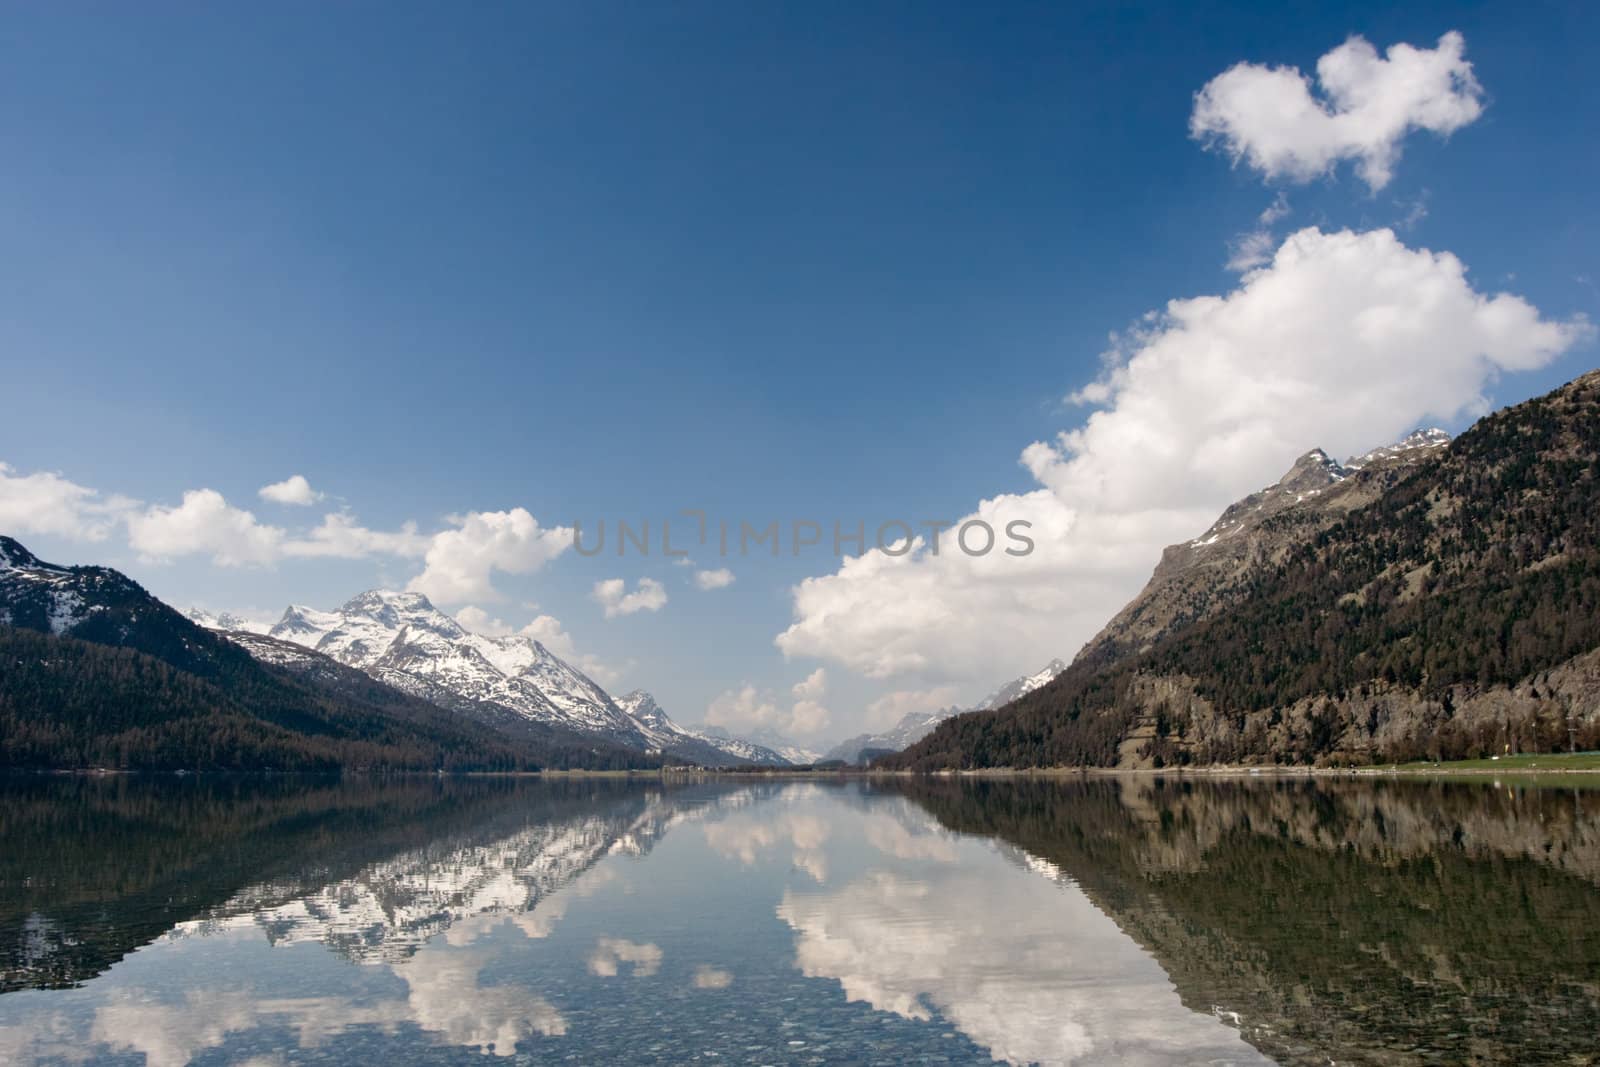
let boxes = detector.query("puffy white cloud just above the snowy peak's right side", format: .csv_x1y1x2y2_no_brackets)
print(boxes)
406,507,573,603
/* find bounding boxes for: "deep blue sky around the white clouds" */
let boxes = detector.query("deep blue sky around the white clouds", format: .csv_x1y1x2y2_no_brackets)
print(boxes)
0,3,1600,736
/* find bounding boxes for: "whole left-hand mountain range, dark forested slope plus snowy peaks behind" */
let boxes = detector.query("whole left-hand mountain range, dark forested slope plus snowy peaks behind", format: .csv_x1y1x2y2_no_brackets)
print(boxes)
0,536,812,769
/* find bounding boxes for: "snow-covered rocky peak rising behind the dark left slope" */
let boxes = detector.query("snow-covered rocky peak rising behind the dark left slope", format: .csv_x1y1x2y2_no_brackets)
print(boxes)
249,589,656,749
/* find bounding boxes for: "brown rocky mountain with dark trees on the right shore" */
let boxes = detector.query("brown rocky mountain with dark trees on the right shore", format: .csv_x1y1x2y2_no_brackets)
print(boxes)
883,371,1600,769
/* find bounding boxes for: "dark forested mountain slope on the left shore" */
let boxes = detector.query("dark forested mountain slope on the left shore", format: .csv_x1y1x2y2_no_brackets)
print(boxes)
0,536,656,771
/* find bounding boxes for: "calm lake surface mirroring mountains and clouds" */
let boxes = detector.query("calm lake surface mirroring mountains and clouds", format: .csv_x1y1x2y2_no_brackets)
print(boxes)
0,779,1600,1067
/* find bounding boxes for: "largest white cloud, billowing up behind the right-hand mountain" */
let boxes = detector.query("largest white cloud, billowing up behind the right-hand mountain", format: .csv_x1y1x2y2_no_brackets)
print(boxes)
776,229,1592,685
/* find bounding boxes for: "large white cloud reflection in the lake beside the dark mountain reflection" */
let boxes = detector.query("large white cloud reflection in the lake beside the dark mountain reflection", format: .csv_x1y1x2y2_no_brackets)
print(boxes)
778,870,1264,1065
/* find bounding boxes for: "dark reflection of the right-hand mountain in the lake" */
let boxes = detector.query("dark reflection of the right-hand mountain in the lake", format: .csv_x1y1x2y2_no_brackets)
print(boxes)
907,777,1600,1064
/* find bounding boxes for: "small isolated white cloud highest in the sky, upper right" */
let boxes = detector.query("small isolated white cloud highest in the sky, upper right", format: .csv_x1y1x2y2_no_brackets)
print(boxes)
1189,32,1483,190
